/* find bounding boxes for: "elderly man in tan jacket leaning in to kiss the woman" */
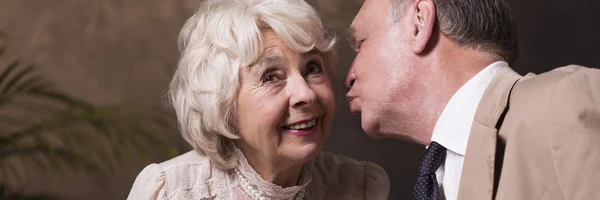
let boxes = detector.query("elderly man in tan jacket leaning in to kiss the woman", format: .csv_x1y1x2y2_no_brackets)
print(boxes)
345,0,600,200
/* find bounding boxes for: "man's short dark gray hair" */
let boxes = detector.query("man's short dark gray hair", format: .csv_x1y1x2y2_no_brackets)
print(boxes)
389,0,519,64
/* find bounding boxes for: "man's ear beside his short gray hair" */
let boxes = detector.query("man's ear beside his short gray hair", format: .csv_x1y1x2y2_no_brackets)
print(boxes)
408,0,436,54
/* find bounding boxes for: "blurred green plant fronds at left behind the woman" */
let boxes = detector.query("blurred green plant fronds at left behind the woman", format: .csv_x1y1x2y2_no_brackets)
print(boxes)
0,29,176,200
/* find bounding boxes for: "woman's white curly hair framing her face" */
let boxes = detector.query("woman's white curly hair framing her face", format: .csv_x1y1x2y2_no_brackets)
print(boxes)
169,0,335,170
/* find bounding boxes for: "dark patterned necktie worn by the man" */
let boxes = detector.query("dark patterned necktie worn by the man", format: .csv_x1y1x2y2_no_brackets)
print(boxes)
413,142,446,200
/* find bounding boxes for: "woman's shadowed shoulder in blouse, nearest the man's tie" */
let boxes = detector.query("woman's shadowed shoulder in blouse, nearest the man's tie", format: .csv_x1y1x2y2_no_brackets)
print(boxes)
314,152,390,199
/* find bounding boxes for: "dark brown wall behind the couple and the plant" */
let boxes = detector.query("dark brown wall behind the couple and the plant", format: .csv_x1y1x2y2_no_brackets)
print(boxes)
0,0,600,200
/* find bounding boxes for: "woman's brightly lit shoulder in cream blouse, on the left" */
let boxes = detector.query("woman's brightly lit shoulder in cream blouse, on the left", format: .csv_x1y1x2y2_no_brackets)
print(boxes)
127,150,224,199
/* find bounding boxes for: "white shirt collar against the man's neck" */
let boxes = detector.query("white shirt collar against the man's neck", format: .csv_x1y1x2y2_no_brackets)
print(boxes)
431,61,508,156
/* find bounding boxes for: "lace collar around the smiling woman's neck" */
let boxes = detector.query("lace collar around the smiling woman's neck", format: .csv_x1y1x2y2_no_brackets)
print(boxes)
234,148,314,199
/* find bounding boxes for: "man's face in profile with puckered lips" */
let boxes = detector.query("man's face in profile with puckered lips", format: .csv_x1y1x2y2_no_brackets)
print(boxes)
345,0,422,137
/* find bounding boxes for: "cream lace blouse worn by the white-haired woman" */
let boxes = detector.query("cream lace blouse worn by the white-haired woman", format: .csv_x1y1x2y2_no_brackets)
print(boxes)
127,150,389,200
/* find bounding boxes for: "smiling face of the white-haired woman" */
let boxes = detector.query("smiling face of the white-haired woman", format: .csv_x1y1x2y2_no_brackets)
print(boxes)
236,30,335,167
